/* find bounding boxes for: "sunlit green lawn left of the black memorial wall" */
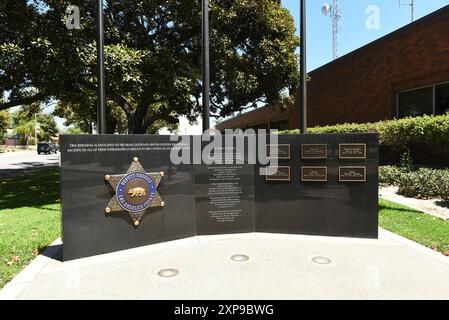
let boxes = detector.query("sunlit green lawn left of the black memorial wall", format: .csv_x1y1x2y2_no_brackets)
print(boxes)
0,169,61,288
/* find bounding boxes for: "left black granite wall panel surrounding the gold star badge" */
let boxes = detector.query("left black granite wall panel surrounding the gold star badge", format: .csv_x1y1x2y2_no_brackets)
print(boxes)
60,135,195,260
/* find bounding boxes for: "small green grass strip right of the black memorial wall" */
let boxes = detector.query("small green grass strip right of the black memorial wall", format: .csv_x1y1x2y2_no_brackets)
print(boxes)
379,199,449,256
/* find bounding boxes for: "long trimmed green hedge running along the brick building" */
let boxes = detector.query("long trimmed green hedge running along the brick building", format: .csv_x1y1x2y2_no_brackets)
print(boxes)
281,114,449,149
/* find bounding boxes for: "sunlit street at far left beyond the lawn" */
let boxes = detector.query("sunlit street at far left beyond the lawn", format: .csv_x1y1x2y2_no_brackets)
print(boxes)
0,151,60,179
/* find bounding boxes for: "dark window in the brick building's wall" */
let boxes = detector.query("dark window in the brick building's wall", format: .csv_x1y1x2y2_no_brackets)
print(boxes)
397,83,449,118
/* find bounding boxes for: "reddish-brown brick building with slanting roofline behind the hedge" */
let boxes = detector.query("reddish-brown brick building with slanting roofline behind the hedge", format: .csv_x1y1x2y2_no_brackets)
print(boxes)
217,6,449,130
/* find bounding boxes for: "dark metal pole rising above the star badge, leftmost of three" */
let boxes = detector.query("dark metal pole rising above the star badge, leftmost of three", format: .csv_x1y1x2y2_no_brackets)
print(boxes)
97,0,106,134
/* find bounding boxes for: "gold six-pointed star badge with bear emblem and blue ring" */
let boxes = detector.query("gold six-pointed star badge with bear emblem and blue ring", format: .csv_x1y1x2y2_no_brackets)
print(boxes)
105,157,165,227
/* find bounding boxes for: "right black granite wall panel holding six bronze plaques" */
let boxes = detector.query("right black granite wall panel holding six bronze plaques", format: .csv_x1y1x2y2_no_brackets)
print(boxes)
255,134,378,238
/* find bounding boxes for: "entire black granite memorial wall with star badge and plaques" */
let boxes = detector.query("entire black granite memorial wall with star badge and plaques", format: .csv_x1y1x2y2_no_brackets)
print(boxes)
60,134,378,261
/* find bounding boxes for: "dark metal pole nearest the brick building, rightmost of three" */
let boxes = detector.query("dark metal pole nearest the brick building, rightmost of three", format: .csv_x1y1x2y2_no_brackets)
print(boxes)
299,0,307,133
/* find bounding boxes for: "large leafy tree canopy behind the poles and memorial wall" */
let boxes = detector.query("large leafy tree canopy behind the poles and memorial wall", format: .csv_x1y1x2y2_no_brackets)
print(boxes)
0,0,299,133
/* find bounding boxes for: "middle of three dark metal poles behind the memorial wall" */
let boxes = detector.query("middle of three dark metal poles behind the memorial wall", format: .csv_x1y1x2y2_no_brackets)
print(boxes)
202,0,210,132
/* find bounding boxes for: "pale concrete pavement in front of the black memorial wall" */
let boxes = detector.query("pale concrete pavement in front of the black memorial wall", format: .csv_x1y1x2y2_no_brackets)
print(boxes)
0,230,449,299
